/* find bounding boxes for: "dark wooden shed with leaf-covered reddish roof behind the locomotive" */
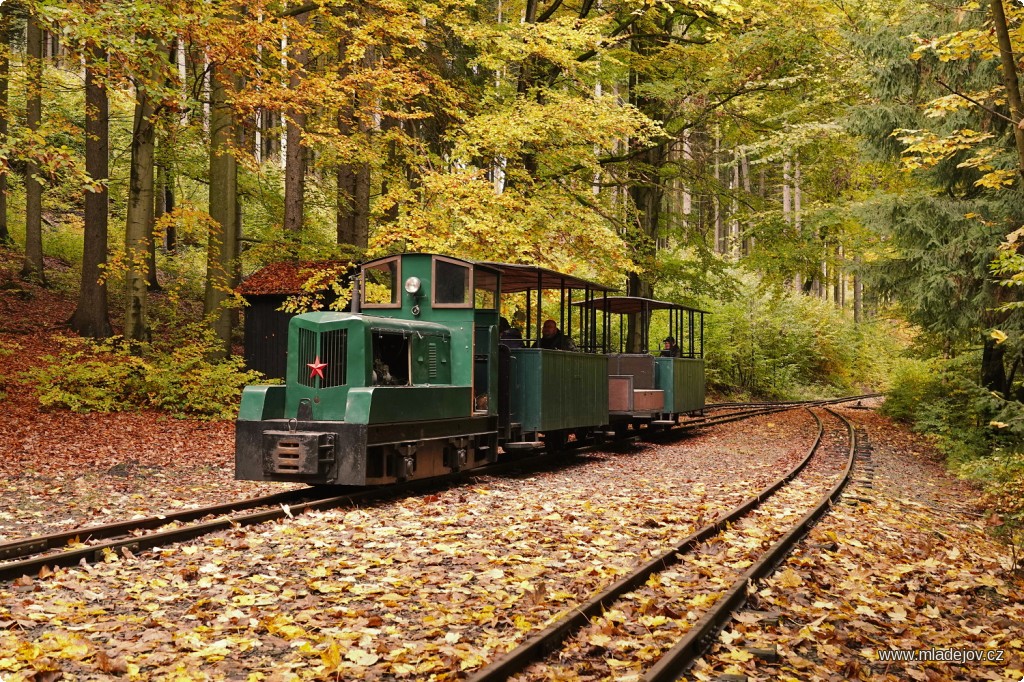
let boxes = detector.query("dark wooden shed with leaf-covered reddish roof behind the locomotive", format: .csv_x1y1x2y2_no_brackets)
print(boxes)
238,261,356,379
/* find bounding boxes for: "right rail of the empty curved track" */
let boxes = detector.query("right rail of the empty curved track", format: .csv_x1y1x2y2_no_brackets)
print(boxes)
643,408,857,682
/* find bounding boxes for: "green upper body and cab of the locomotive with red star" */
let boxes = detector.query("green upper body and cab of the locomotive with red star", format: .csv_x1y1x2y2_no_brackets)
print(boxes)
239,254,498,424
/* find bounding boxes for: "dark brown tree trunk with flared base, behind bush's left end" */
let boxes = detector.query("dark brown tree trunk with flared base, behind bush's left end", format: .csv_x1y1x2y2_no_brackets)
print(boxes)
69,45,113,339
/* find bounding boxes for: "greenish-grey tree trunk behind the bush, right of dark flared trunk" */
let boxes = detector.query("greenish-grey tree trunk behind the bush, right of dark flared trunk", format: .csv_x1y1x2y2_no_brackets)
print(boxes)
125,85,155,341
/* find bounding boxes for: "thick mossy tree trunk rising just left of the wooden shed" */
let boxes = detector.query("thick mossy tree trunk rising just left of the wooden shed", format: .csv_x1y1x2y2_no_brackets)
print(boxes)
204,65,239,357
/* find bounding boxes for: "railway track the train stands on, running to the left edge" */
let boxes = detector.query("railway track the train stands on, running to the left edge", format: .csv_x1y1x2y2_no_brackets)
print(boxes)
0,396,866,581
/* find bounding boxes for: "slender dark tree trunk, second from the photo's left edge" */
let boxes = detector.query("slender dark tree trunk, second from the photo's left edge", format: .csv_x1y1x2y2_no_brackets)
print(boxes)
22,15,46,285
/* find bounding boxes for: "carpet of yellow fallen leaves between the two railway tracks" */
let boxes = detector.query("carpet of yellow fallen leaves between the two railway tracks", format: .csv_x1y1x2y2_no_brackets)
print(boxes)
0,415,810,679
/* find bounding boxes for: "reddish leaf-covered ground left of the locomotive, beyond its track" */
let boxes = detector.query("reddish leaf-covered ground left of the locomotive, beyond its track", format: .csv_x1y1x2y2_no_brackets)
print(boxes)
0,249,296,543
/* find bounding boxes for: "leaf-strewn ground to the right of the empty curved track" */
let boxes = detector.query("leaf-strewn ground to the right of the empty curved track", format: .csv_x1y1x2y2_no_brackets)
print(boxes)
691,411,1024,682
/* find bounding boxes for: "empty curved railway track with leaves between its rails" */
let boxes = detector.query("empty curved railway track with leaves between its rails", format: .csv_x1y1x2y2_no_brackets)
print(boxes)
469,408,858,682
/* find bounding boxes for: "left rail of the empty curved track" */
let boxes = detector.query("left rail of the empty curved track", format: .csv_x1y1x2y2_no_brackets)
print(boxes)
469,408,824,682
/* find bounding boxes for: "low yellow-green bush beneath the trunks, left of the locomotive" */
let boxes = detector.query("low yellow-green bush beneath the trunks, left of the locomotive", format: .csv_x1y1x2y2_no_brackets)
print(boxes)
28,323,260,419
